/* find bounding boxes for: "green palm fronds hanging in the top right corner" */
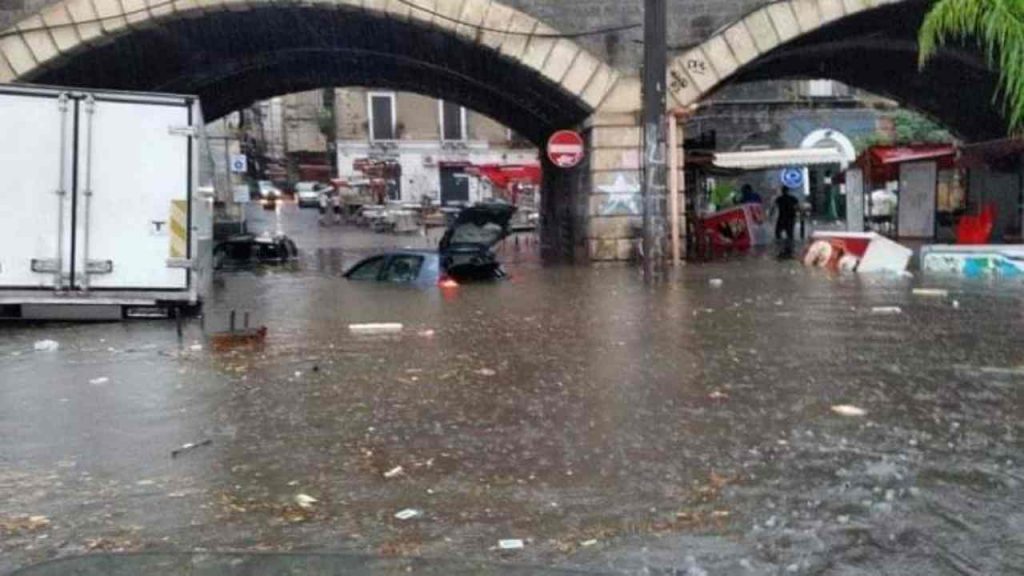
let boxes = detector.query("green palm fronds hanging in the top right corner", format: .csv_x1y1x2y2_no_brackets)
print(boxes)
918,0,1024,132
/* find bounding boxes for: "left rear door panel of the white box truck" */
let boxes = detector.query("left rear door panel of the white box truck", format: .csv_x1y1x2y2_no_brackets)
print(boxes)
0,90,74,290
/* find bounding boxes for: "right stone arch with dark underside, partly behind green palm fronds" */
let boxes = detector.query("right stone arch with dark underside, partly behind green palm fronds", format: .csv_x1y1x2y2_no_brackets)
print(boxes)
668,0,1007,140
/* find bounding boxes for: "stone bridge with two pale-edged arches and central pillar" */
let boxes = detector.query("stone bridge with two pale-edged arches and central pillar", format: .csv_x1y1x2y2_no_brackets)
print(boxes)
0,0,1005,259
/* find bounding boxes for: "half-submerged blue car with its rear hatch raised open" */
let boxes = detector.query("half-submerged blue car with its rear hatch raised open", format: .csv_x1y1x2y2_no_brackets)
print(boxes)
345,204,516,285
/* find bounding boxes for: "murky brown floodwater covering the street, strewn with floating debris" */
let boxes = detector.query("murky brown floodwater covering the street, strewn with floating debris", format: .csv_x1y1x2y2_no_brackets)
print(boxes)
0,207,1024,576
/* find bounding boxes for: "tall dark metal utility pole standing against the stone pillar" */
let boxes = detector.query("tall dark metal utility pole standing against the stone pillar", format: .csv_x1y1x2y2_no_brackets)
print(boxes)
642,0,668,282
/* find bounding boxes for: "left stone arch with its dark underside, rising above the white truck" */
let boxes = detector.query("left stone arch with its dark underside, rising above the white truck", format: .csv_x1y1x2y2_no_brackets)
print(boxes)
0,0,639,257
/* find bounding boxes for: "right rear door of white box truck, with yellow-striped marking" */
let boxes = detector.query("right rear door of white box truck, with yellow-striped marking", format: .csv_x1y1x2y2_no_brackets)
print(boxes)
74,95,193,290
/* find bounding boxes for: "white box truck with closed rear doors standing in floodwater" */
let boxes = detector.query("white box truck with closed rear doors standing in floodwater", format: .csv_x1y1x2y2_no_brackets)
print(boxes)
0,85,213,319
